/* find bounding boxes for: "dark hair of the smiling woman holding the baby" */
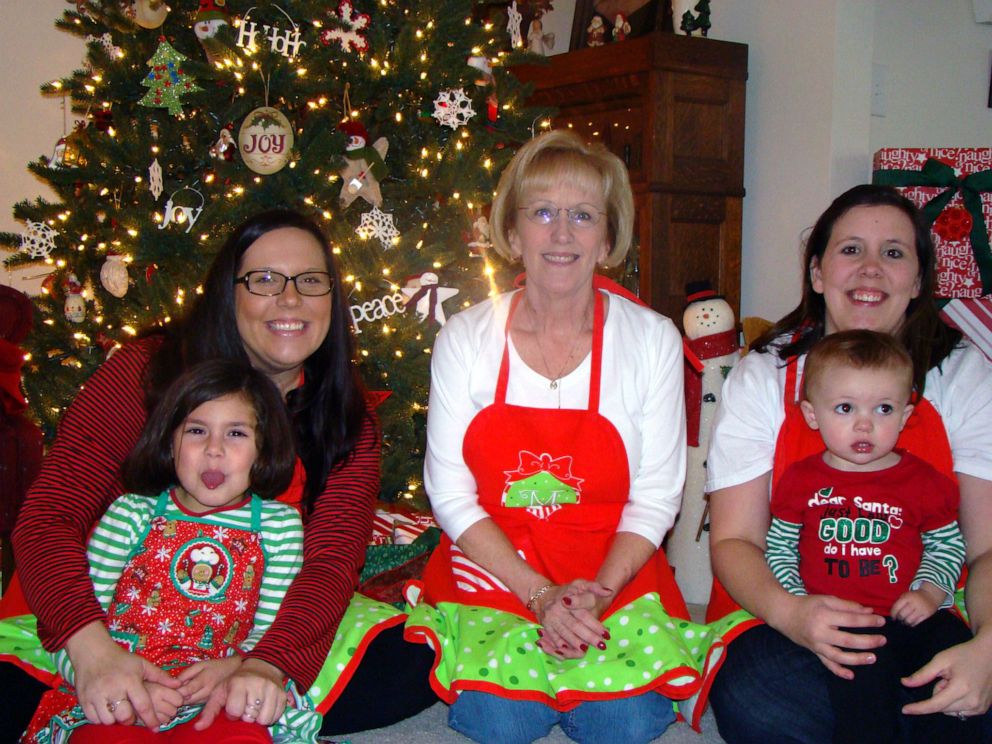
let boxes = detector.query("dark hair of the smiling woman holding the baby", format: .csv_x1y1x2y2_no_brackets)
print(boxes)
751,184,961,394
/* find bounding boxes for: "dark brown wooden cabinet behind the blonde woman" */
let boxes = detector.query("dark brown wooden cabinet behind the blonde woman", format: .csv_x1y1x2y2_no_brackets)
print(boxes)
513,31,747,324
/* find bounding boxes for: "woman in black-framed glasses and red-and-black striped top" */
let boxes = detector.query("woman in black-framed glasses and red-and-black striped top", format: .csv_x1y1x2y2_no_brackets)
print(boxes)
0,210,436,741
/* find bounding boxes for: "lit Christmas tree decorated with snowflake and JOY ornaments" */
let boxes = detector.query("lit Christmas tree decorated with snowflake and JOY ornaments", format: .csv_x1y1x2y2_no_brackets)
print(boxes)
0,0,546,505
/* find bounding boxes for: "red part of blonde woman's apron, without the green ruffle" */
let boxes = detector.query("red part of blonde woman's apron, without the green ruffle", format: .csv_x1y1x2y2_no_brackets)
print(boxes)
424,292,688,619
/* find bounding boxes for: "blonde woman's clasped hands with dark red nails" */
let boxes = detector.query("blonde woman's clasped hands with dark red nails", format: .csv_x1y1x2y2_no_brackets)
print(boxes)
534,579,613,659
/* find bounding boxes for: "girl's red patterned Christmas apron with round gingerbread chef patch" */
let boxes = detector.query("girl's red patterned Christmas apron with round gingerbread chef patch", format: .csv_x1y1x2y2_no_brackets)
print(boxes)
22,491,320,744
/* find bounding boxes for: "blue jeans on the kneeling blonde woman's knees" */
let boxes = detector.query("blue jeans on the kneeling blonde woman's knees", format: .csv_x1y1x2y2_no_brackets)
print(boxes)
448,691,675,744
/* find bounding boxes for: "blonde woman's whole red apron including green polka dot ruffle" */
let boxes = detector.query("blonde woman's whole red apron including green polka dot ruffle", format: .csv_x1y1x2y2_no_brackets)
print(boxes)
406,292,722,728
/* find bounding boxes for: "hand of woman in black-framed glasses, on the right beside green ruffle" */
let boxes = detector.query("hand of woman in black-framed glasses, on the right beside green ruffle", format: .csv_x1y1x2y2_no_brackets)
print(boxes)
194,659,287,731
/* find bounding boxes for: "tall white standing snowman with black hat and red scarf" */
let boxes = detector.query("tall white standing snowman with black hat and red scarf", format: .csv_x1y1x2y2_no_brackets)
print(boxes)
665,281,740,604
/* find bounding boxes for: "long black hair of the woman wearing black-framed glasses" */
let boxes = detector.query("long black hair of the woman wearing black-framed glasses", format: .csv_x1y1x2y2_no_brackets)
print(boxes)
146,209,374,513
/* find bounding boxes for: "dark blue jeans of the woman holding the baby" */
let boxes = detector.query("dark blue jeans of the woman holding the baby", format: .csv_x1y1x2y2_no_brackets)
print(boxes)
710,625,992,744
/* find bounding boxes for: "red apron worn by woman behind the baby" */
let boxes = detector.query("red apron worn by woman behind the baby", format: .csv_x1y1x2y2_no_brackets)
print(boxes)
706,357,967,643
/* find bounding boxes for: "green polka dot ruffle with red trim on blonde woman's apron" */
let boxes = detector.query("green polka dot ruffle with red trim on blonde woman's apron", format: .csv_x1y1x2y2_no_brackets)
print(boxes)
407,584,723,721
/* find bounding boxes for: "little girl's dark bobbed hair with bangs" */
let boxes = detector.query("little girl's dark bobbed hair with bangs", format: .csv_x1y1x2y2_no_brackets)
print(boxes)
122,359,296,499
